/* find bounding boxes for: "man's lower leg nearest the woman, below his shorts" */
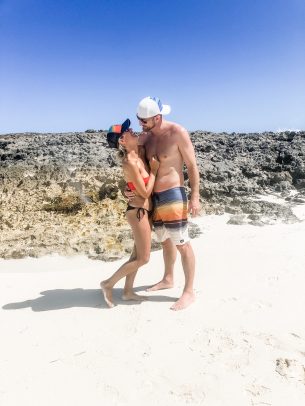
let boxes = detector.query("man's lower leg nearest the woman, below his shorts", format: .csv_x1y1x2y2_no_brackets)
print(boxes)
147,238,177,292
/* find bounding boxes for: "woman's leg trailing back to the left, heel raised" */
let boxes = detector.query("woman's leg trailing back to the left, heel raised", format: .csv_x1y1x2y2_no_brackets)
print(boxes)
101,210,151,307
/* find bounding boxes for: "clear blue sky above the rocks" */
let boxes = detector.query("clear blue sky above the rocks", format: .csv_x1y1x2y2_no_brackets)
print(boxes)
0,0,305,134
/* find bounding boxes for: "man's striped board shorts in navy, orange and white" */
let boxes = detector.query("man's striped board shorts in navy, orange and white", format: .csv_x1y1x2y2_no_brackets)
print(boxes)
152,187,190,245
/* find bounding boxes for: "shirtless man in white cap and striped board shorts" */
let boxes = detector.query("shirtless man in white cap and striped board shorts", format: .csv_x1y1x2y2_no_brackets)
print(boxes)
129,97,200,310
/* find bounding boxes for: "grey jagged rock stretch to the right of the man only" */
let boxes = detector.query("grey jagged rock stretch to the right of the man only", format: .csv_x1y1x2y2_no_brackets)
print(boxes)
191,131,305,217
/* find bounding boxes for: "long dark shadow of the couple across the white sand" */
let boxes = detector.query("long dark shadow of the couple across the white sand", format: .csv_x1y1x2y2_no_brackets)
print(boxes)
2,286,177,312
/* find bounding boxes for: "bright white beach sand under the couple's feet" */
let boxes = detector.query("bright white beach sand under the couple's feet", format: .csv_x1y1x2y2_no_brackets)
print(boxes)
0,207,305,406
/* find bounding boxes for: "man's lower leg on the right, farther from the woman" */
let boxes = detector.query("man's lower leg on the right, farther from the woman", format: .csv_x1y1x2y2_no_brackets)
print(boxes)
171,242,195,310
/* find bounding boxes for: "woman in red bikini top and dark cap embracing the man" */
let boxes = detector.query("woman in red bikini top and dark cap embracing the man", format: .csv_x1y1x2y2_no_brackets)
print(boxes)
100,119,160,307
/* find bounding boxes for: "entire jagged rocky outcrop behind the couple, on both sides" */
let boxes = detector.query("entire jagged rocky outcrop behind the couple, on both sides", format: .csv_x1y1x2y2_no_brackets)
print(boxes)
0,131,305,260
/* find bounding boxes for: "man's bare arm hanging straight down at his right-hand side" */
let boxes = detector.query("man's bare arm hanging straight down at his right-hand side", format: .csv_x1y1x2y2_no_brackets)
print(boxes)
177,127,200,216
